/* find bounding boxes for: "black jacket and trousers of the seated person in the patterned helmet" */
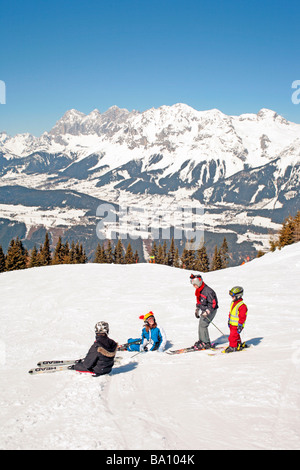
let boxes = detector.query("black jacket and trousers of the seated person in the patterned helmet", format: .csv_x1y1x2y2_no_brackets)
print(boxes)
75,334,118,375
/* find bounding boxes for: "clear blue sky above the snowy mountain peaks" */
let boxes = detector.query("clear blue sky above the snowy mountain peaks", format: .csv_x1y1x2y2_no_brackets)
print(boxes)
0,0,300,135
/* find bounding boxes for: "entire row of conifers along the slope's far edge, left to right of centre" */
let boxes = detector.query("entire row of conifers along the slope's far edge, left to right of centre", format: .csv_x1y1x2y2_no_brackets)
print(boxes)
0,233,228,272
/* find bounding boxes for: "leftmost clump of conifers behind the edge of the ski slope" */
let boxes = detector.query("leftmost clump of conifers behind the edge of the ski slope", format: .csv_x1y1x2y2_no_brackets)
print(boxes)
0,233,87,272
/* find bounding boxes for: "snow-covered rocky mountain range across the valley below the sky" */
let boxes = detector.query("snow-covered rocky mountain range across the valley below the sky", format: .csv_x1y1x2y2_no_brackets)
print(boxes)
0,104,300,260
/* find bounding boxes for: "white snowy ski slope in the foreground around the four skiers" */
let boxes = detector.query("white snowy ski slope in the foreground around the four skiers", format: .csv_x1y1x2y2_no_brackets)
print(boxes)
0,243,300,450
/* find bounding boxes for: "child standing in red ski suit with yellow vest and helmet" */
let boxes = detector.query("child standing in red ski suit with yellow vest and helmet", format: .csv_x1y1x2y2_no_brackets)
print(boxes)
224,286,248,353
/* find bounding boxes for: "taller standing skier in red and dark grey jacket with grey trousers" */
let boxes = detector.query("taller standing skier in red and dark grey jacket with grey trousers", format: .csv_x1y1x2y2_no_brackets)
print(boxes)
190,274,219,349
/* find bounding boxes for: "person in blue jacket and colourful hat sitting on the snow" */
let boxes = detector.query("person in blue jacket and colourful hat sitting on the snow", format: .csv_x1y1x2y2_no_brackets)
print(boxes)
127,312,167,352
